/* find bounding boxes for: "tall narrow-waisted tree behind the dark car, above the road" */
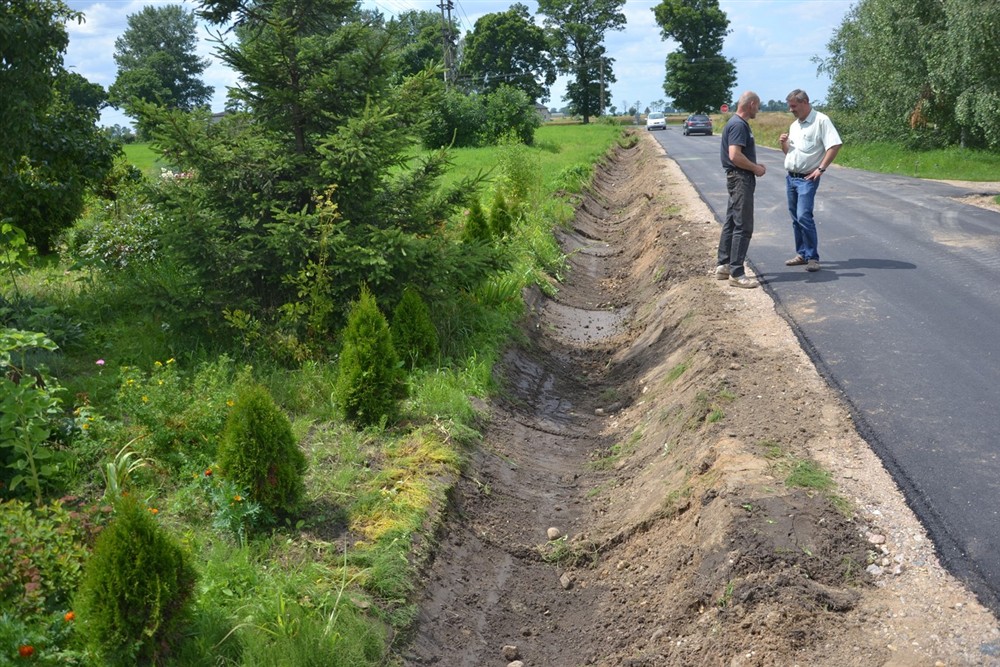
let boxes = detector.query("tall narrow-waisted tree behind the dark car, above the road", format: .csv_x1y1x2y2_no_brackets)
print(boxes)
653,0,736,112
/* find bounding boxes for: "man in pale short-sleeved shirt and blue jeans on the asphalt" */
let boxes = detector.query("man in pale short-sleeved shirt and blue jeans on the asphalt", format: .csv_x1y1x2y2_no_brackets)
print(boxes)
778,88,843,271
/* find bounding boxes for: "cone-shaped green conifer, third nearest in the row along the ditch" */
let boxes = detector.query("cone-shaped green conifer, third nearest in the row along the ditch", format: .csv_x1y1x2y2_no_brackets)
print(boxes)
334,288,403,426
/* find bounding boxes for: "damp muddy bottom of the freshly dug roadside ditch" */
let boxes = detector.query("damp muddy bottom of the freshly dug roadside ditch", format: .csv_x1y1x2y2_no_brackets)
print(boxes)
404,142,648,667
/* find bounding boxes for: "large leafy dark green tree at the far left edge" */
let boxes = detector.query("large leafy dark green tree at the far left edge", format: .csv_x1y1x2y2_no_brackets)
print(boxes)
0,0,113,254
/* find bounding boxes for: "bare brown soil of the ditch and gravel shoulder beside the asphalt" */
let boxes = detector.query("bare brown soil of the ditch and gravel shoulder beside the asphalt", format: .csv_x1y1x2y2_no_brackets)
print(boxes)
398,132,1000,667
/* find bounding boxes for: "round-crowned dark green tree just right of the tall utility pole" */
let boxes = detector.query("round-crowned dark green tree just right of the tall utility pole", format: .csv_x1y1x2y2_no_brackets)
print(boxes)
460,3,556,102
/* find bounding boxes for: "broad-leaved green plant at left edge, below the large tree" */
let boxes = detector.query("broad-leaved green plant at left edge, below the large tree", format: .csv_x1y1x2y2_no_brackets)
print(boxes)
0,328,66,503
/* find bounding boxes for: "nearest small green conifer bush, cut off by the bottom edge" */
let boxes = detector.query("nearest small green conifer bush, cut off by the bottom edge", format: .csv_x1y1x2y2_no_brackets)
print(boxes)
76,497,196,666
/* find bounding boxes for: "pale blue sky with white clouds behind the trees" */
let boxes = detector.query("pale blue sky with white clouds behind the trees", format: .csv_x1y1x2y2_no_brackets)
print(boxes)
65,0,853,125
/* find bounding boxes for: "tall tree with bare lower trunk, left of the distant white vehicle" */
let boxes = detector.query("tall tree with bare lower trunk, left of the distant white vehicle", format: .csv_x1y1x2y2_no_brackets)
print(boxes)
538,0,625,123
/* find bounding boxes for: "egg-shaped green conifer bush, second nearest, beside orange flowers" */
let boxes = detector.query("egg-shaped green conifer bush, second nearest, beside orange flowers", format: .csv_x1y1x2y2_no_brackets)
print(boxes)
213,384,306,515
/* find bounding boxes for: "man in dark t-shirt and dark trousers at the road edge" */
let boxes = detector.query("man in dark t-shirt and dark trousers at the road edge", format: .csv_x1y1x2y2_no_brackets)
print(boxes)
715,90,767,289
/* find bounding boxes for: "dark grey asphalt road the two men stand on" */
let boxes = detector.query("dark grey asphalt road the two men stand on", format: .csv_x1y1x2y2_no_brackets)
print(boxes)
653,127,1000,615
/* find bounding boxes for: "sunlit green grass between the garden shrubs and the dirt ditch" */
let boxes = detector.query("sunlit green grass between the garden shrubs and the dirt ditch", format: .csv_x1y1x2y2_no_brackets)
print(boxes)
0,123,635,667
